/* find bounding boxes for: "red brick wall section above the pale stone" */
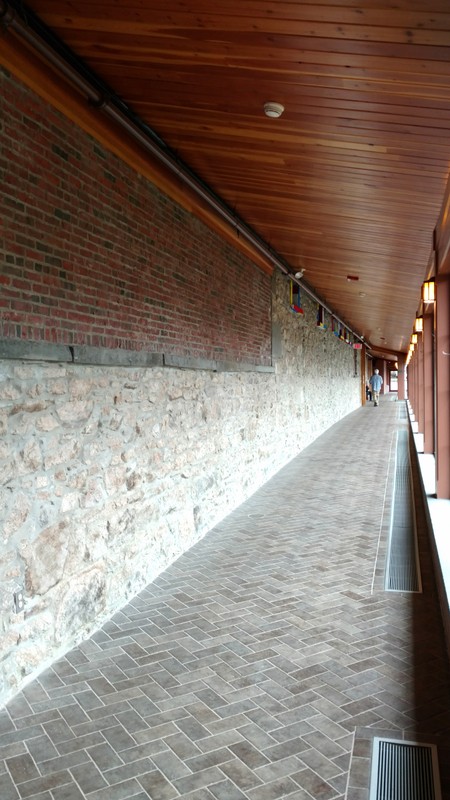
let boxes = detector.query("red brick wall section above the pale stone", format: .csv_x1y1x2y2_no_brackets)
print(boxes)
0,69,271,364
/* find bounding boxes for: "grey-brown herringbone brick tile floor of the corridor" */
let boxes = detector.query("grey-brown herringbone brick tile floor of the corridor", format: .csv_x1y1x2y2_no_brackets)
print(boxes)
0,397,450,800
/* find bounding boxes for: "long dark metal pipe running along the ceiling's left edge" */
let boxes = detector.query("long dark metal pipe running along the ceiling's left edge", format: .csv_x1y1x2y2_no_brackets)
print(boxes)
0,0,365,343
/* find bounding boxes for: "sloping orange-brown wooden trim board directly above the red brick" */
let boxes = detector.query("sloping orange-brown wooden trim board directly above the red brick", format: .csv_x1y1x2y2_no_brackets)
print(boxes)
0,28,274,275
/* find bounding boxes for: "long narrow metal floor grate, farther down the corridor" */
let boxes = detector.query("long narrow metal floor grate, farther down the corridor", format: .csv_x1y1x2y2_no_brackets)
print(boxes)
385,430,422,592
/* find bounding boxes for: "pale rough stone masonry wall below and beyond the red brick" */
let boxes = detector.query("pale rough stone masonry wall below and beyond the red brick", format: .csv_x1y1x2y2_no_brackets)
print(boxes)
0,275,359,701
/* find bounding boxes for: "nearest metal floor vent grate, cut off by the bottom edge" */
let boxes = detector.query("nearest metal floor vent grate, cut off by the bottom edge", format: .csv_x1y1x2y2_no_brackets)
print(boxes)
369,738,442,800
